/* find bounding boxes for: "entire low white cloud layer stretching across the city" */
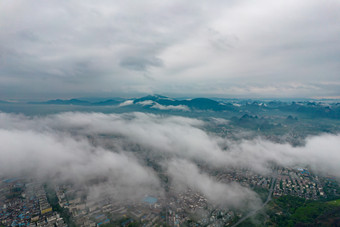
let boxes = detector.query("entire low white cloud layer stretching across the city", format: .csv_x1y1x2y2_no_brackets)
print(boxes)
0,112,340,208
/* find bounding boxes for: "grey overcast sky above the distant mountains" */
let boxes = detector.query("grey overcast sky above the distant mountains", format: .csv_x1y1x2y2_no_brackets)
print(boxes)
0,0,340,99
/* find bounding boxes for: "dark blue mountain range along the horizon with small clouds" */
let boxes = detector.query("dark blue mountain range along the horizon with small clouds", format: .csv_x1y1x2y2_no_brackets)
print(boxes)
0,95,340,118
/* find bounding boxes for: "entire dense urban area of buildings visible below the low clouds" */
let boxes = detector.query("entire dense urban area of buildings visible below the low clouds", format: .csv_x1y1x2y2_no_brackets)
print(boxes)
0,164,340,227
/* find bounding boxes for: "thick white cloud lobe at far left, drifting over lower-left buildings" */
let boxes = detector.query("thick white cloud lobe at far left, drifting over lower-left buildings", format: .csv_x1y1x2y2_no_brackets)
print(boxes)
0,114,162,200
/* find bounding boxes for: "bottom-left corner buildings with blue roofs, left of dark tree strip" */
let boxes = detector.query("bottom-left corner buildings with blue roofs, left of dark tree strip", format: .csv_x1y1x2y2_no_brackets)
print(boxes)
0,178,67,227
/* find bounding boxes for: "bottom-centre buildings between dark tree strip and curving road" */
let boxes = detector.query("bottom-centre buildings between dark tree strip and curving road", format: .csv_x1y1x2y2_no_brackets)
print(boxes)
56,185,240,227
